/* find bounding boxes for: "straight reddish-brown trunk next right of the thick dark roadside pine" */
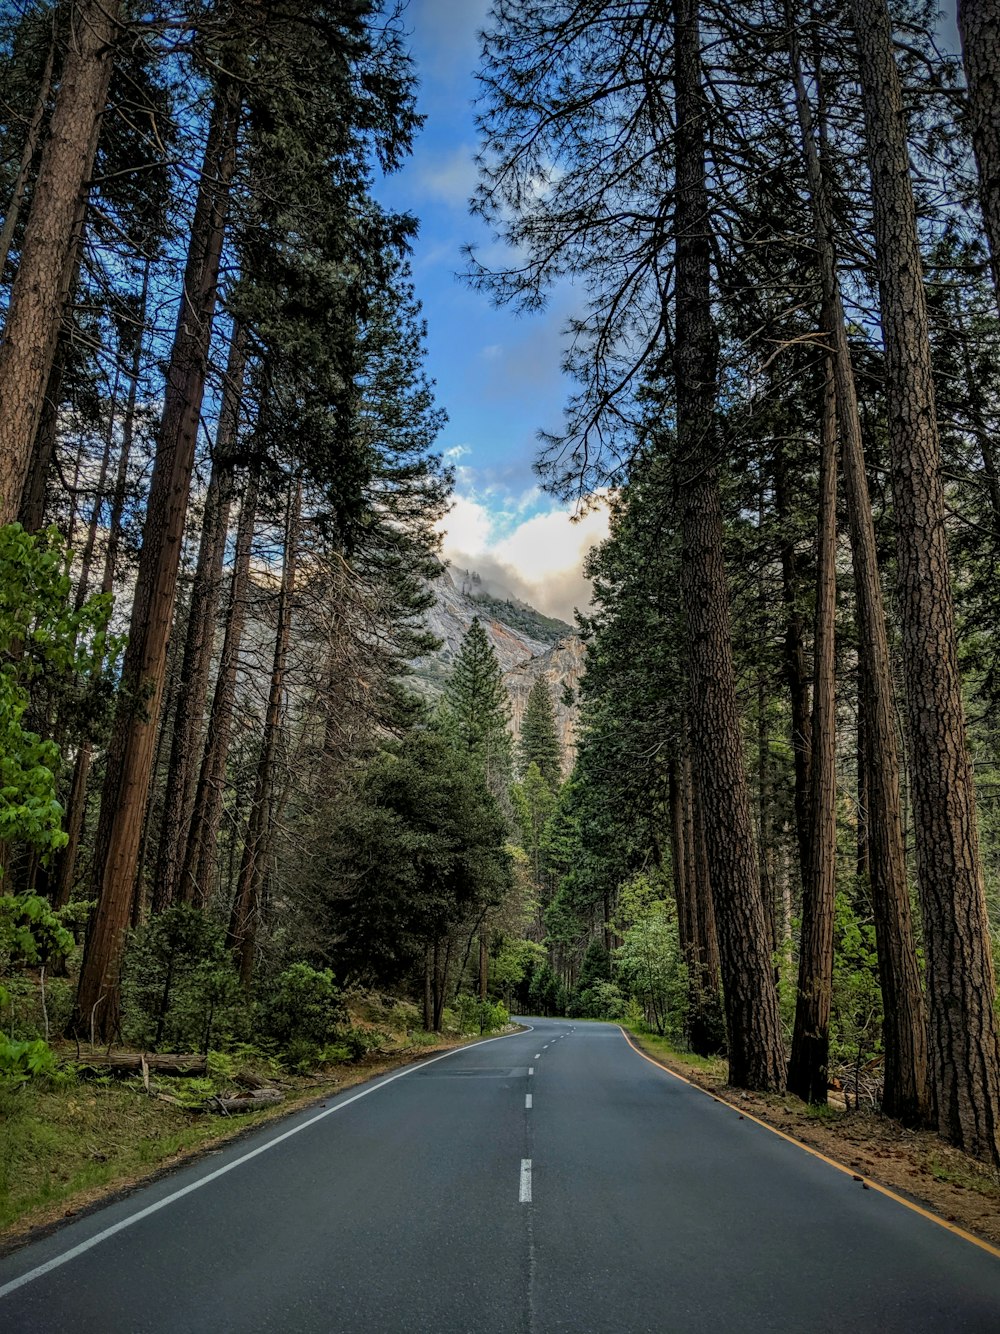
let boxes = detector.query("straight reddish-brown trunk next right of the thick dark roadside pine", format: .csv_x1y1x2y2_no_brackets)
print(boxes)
788,358,837,1103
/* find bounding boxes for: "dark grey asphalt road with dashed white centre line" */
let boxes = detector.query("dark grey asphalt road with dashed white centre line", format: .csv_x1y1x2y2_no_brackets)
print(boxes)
0,1019,1000,1334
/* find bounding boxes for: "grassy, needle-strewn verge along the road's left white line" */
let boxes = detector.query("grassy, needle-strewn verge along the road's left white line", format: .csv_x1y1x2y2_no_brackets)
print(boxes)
0,1008,501,1254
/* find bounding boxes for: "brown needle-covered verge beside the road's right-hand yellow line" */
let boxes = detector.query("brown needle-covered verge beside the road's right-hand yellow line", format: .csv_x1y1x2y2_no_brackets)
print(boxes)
629,1030,1000,1246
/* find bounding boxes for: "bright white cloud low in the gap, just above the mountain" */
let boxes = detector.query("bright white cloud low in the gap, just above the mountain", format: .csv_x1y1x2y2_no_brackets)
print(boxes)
441,488,608,624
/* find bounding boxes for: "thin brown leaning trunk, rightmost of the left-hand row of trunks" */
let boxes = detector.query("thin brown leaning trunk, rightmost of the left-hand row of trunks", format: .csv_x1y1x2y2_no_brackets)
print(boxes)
227,482,303,988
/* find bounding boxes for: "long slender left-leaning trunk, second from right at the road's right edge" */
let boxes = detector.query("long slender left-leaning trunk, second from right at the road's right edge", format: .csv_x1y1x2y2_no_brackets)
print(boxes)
787,7,929,1125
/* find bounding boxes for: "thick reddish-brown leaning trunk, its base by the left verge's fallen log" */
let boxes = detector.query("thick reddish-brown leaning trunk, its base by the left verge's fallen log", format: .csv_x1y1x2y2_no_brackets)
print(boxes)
77,88,240,1039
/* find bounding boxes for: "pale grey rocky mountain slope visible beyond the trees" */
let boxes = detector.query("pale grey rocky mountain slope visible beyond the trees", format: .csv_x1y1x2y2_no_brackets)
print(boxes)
411,566,584,774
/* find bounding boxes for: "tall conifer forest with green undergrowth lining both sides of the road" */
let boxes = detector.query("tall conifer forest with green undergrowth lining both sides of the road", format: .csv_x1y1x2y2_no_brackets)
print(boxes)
0,0,1000,1221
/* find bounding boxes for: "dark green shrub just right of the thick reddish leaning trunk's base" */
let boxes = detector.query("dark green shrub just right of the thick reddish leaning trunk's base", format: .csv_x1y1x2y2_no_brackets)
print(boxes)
121,903,244,1051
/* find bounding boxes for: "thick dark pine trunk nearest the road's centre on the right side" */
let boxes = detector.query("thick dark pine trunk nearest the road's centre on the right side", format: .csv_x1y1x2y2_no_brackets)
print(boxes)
675,0,785,1089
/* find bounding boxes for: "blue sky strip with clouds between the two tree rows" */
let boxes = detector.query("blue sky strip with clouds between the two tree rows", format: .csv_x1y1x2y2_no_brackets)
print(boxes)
379,0,607,622
